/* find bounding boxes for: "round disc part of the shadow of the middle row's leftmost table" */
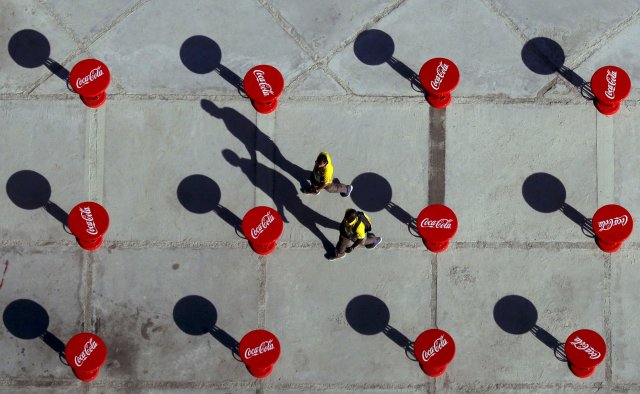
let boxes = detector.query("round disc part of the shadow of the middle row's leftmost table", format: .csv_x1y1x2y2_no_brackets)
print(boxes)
6,170,51,209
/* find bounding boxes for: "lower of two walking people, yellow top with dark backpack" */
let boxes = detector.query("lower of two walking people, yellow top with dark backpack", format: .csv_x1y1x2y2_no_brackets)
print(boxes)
329,208,382,261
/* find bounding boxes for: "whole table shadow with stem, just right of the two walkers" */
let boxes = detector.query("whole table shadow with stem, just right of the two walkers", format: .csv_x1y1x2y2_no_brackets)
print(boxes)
351,172,420,237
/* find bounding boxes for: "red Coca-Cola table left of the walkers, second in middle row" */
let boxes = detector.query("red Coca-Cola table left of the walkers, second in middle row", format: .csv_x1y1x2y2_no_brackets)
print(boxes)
242,206,284,255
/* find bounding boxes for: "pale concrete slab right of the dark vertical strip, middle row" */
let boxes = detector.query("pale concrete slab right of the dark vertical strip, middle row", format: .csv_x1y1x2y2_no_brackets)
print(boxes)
445,104,597,242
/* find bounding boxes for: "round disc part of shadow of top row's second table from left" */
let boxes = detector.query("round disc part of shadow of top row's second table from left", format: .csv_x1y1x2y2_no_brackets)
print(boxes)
180,36,222,74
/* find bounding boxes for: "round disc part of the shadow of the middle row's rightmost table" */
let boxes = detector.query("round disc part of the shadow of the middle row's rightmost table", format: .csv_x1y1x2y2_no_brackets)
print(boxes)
522,172,567,213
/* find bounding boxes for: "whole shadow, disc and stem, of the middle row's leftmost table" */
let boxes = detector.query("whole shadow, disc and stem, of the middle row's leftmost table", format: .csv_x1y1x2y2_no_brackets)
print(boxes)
6,170,71,234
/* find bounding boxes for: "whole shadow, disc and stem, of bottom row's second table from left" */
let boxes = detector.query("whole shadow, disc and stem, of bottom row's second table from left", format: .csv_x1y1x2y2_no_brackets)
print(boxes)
173,295,242,361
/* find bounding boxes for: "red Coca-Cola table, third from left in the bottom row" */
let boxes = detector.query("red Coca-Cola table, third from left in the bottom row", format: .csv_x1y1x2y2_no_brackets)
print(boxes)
413,328,456,378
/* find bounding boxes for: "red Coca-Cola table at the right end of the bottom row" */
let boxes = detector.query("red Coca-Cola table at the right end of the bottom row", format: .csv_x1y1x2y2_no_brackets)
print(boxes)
564,329,607,378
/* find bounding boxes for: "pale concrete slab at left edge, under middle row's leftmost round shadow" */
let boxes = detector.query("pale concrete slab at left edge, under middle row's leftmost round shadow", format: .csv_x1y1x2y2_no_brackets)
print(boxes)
0,100,87,241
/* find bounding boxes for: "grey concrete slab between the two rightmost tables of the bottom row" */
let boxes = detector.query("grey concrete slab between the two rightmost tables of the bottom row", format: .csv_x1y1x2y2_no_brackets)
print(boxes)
438,248,606,384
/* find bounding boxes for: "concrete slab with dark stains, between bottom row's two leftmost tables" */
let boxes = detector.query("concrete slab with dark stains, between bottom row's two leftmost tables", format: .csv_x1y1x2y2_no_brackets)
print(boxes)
92,249,260,382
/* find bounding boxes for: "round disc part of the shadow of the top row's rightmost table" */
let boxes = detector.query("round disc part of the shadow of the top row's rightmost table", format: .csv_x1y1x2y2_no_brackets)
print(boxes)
520,37,565,75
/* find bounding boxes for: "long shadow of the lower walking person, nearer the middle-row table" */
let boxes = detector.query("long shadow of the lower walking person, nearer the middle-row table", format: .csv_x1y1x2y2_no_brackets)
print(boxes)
222,149,340,255
